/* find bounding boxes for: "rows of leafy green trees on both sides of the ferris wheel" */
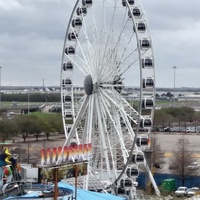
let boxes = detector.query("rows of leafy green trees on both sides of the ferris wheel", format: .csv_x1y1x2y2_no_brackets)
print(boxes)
0,103,200,141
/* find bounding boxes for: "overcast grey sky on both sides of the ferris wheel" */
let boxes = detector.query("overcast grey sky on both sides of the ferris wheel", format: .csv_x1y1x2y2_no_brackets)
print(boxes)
0,0,200,87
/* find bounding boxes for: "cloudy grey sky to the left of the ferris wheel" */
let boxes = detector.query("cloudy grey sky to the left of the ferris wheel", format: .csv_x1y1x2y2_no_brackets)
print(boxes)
0,0,73,85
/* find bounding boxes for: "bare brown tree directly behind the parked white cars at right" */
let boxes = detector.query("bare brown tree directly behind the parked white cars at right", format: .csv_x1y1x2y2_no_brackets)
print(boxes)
170,137,198,186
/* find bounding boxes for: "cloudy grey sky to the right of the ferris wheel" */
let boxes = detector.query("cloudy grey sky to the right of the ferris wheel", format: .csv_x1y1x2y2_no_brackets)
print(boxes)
142,0,200,87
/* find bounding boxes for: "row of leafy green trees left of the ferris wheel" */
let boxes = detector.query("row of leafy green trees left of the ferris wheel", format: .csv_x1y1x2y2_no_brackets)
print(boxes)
0,113,63,142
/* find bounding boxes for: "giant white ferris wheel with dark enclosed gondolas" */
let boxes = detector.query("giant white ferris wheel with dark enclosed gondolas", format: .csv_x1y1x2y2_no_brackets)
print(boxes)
61,0,159,197
